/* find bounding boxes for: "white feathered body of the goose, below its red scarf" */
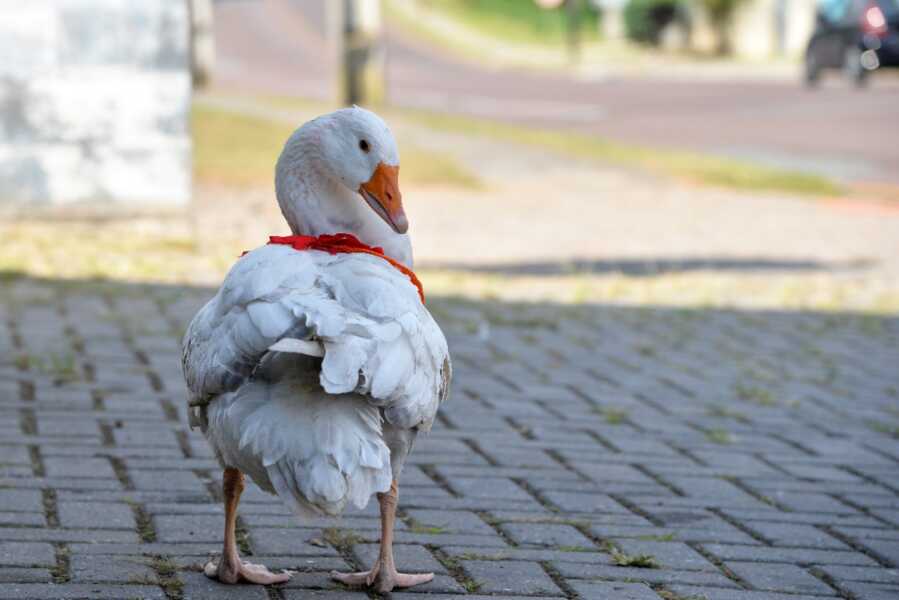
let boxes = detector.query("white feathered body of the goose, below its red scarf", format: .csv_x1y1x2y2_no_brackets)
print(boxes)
184,245,449,515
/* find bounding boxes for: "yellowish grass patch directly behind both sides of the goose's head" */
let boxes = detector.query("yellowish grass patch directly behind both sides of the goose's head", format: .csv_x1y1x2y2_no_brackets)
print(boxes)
192,103,483,189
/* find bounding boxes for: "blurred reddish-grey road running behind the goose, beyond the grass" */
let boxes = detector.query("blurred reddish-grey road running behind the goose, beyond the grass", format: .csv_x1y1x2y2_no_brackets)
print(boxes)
215,0,899,183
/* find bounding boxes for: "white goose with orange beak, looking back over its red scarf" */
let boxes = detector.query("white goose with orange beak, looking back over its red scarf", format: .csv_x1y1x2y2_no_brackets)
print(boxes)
183,107,451,591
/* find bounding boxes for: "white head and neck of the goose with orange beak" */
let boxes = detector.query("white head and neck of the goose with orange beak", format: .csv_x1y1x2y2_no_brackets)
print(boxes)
275,106,411,262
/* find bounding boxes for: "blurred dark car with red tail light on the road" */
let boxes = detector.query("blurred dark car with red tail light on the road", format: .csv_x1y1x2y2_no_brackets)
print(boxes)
805,0,899,86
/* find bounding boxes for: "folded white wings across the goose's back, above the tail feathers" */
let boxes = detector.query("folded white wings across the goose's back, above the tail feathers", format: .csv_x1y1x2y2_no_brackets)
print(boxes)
182,245,451,429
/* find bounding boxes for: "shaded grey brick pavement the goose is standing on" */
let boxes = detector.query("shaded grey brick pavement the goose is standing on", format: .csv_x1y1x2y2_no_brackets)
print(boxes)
0,278,899,600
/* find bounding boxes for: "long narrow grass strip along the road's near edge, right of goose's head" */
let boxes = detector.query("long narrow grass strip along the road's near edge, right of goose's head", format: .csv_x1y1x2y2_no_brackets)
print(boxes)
403,111,846,196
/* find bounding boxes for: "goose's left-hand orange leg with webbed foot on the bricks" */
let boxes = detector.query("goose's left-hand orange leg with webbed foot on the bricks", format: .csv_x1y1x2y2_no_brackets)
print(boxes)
203,468,292,585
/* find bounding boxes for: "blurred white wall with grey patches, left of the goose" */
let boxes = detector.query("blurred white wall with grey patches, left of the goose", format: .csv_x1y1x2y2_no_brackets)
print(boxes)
0,0,191,208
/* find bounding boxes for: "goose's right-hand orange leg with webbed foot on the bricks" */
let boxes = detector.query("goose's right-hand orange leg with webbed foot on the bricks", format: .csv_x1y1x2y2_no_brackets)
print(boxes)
331,479,434,592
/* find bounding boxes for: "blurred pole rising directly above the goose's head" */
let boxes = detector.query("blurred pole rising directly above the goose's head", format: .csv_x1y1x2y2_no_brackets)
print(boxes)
328,0,385,106
